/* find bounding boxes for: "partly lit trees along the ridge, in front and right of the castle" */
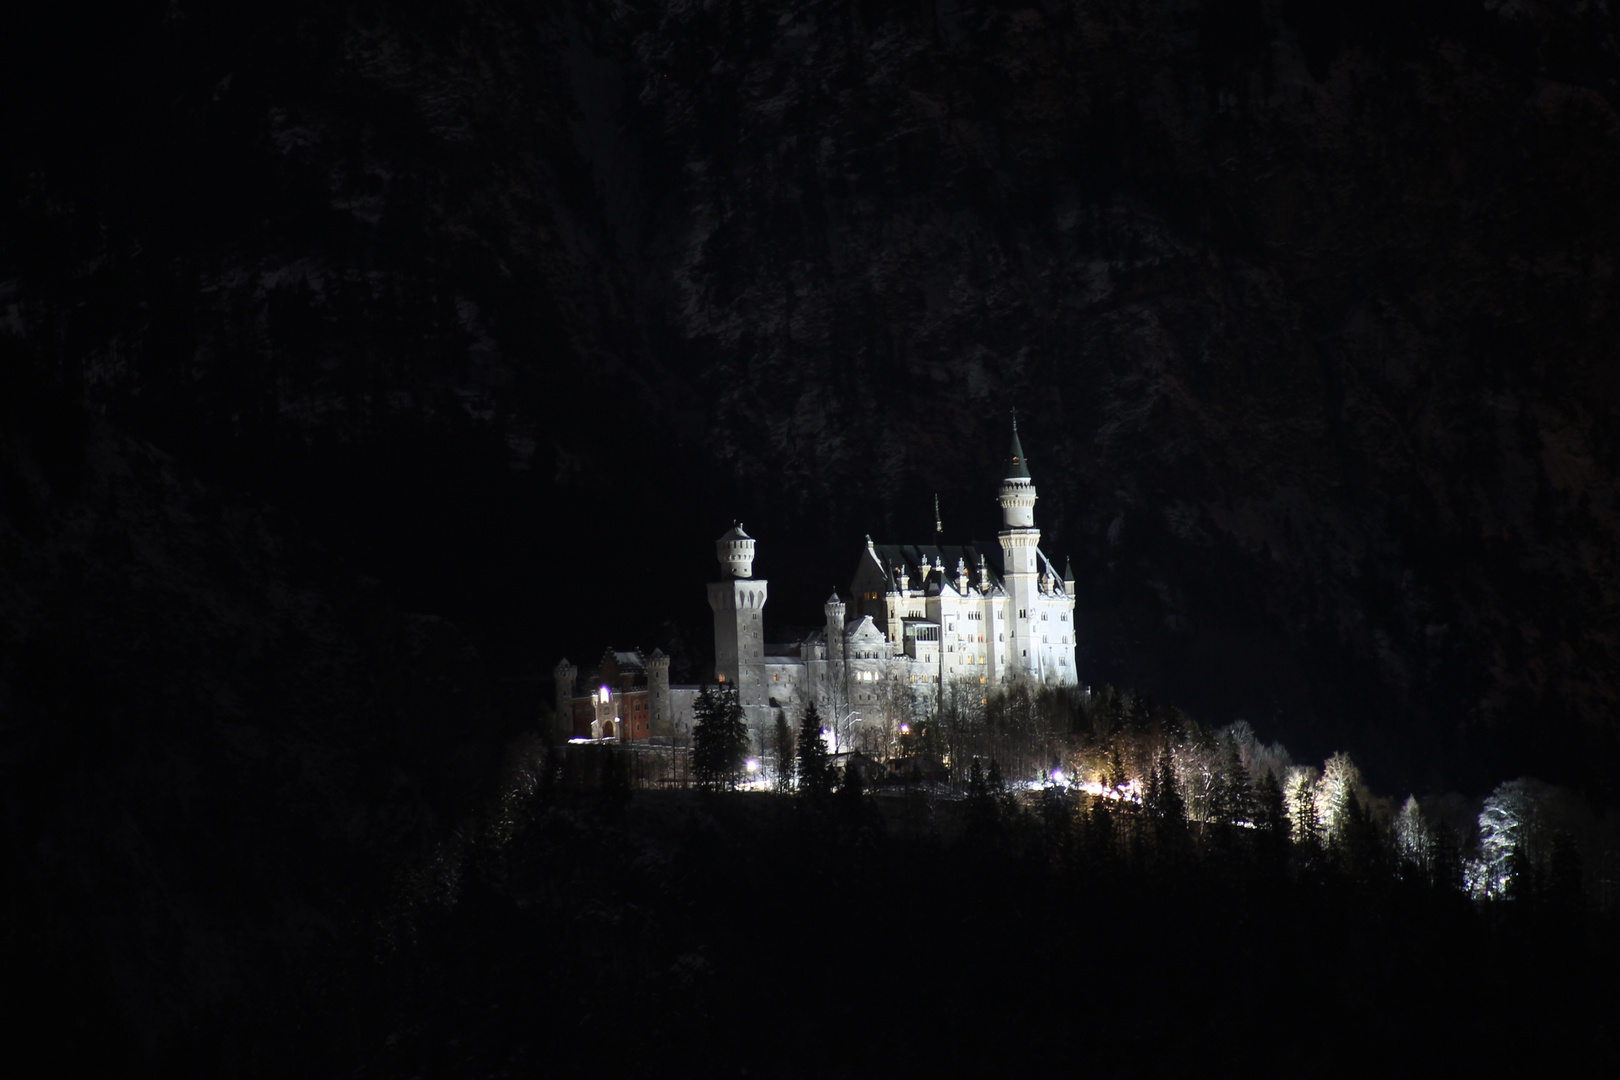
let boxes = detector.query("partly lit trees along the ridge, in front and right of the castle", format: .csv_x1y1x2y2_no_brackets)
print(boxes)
693,682,1620,910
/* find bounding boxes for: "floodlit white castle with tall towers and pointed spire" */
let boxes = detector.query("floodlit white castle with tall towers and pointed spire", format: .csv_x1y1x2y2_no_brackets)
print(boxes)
556,421,1079,748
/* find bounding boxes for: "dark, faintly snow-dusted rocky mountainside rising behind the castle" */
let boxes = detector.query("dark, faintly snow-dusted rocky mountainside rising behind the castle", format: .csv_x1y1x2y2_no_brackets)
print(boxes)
0,0,1620,787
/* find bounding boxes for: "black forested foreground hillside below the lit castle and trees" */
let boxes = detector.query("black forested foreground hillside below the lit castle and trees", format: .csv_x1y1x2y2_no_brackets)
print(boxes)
175,751,1620,1077
